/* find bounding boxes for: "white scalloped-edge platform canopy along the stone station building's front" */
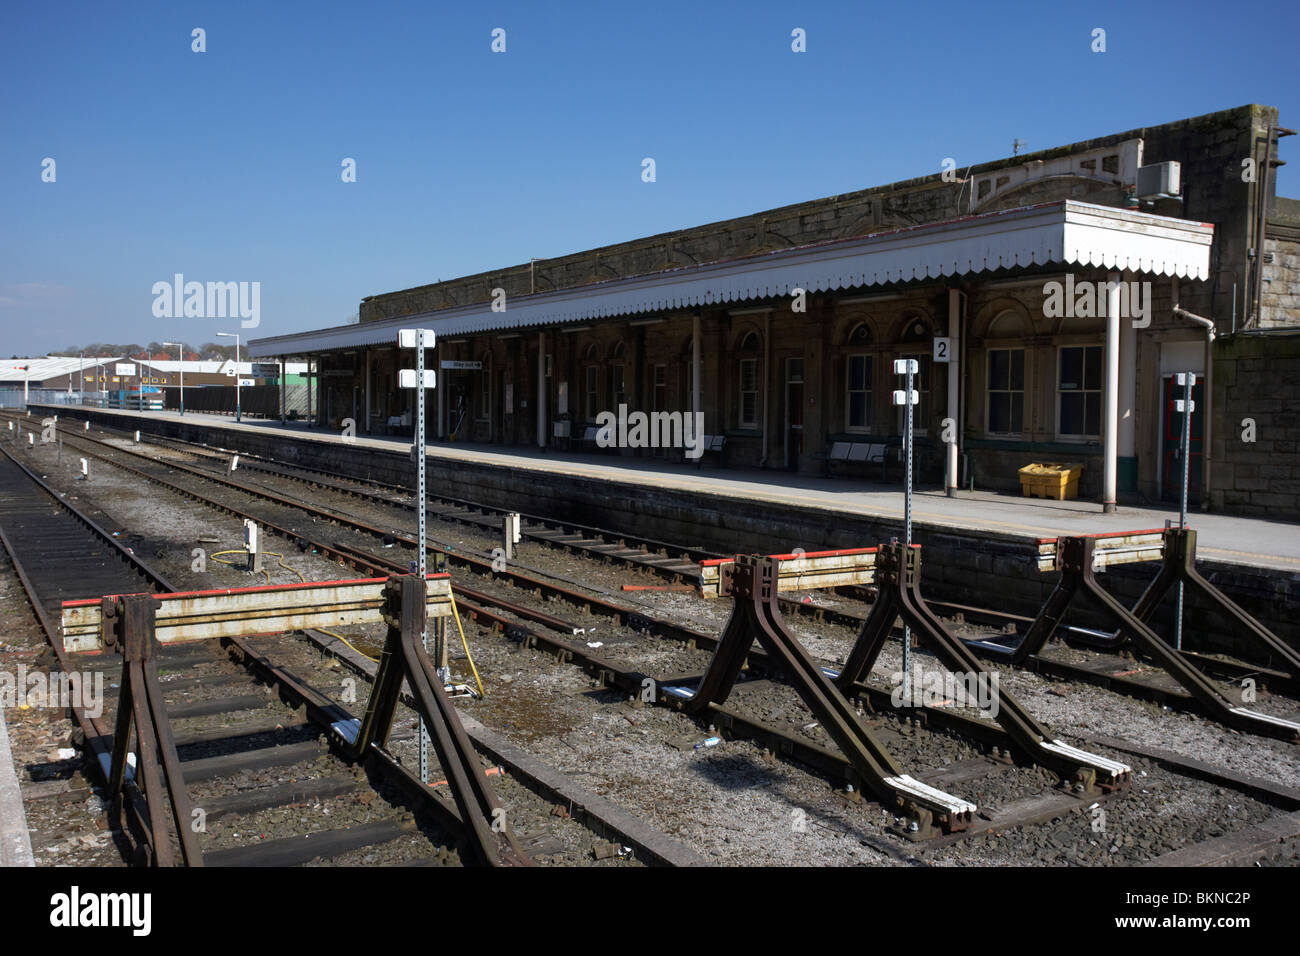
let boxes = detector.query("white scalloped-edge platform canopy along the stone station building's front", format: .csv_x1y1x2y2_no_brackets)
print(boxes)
248,200,1214,358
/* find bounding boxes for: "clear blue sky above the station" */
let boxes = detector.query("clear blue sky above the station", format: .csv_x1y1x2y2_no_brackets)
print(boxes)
0,0,1300,355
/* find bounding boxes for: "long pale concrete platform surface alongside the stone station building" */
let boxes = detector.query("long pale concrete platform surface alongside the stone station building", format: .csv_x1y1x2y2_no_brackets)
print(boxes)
32,407,1300,571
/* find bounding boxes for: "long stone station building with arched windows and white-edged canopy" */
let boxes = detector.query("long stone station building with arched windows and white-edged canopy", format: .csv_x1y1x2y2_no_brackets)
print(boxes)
248,105,1300,515
